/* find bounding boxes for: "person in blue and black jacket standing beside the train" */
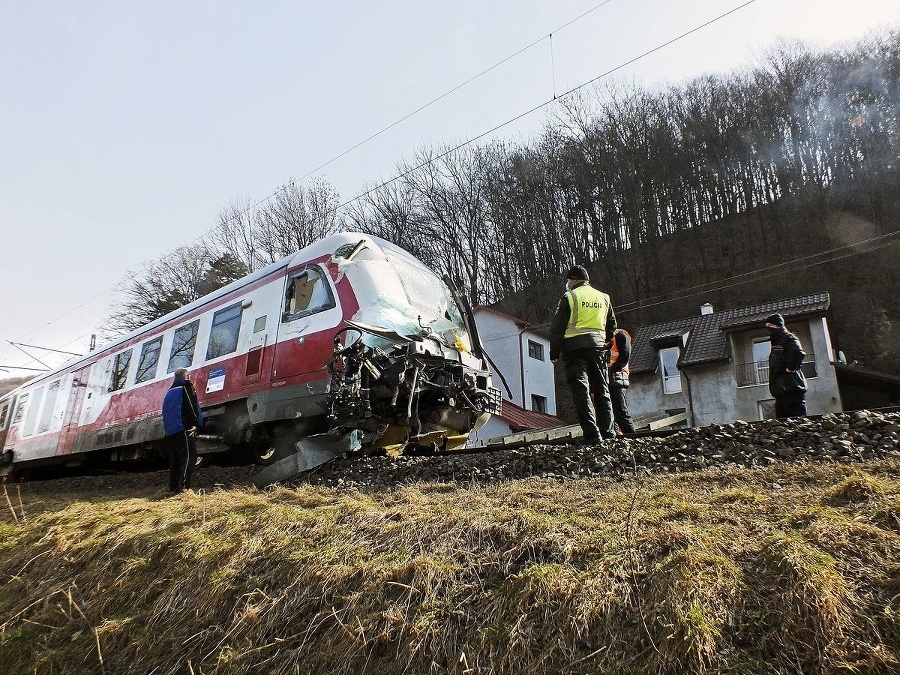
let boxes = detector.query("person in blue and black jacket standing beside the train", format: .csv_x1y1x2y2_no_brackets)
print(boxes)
163,368,203,494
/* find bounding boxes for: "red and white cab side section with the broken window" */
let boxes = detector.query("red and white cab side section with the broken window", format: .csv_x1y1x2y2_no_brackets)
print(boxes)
272,265,342,379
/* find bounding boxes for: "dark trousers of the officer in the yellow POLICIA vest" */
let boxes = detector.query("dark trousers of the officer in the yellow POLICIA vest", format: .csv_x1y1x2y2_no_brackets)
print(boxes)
563,349,615,439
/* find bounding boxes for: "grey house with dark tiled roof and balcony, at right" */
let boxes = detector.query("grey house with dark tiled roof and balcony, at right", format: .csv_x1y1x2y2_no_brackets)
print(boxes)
628,293,842,426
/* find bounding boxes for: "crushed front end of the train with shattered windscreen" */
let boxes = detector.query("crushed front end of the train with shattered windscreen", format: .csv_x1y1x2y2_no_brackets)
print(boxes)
253,235,501,483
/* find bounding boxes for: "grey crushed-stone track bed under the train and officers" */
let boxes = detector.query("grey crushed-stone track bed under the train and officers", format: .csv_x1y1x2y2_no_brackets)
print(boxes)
7,408,900,490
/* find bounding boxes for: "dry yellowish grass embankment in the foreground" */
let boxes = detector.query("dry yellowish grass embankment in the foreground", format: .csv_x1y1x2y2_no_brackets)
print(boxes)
0,462,900,674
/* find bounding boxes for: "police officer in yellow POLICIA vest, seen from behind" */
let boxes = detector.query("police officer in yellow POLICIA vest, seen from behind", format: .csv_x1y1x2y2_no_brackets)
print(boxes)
550,265,616,443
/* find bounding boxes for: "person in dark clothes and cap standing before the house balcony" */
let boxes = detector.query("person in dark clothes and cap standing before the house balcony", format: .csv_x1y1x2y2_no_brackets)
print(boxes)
766,314,806,417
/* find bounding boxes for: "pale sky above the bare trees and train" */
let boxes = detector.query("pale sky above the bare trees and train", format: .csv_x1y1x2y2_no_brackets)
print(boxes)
0,0,900,377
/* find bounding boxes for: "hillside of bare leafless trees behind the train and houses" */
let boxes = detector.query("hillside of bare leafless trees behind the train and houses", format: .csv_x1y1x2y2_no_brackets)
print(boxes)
113,28,900,372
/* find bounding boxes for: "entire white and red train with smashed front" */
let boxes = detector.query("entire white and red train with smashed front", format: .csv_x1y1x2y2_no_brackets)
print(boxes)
0,233,500,471
